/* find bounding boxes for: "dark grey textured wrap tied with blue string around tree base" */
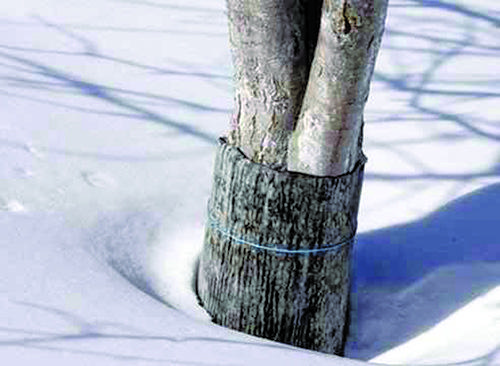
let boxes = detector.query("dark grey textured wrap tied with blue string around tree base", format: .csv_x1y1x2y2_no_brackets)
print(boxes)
198,139,365,354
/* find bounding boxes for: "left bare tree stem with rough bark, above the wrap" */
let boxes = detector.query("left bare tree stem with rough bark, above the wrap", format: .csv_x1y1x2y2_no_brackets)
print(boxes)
227,0,322,169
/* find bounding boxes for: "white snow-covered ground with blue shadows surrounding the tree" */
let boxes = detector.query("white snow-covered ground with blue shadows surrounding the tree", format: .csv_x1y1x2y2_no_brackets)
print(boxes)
0,0,500,366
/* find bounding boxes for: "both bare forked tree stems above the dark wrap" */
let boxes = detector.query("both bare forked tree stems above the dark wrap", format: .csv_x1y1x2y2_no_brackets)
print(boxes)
227,0,387,176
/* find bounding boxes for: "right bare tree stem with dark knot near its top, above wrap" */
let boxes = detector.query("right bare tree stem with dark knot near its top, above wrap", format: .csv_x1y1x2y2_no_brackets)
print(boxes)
287,0,387,176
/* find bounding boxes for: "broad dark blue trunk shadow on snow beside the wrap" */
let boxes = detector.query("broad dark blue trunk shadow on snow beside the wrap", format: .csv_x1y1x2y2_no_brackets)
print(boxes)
347,184,500,360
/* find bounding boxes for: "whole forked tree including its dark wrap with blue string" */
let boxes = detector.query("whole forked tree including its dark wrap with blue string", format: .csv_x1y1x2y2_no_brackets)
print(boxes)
198,0,387,354
